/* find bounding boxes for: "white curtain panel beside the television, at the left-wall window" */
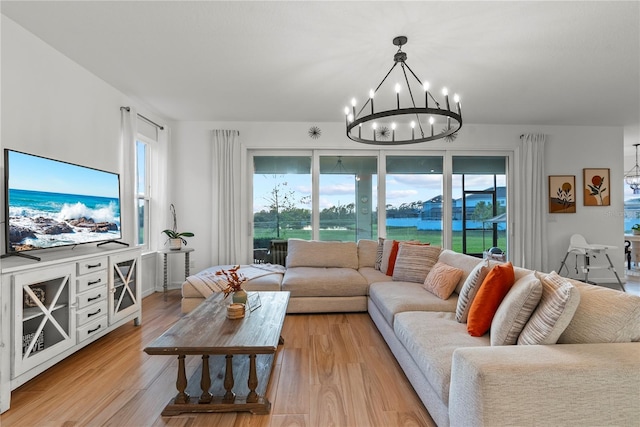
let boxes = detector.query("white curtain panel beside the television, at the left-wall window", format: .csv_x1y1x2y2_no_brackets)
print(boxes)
120,107,138,245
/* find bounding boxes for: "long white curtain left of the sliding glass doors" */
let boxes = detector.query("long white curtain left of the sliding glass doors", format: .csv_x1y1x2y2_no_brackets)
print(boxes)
211,129,245,265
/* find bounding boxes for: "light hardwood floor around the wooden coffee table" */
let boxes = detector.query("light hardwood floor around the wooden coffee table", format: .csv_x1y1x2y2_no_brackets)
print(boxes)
0,291,435,427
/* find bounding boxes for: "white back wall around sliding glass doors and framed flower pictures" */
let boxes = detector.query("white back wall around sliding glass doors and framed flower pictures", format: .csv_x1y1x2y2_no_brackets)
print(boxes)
169,122,624,282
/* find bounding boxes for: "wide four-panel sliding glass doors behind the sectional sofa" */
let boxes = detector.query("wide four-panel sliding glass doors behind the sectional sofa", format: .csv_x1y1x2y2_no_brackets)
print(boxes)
252,150,509,256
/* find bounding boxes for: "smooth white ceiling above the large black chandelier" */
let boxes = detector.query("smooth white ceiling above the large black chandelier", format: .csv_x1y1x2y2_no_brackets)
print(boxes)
1,1,640,147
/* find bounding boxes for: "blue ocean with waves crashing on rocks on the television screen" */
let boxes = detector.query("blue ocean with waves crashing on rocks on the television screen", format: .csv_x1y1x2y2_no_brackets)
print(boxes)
9,188,121,251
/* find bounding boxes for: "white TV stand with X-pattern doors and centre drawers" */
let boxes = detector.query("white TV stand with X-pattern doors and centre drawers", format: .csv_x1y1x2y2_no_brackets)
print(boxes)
0,245,142,413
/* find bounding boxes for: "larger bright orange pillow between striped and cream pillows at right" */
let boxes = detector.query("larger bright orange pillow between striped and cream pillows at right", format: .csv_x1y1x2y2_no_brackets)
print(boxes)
467,262,515,337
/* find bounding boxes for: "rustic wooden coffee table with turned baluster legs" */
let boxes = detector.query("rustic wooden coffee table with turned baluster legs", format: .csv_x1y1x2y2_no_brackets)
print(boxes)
144,292,289,415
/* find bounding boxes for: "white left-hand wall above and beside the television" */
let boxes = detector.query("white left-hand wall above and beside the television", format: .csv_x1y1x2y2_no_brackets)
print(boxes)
0,15,167,295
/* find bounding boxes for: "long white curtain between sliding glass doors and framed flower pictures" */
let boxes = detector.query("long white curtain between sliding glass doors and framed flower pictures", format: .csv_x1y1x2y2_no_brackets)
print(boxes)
518,134,548,271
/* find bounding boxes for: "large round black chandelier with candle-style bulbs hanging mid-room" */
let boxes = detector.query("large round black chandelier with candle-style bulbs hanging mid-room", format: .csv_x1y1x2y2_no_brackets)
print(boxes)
344,36,462,145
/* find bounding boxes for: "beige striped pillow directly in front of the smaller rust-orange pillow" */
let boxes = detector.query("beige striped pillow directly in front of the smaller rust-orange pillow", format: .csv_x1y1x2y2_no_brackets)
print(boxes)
393,243,440,287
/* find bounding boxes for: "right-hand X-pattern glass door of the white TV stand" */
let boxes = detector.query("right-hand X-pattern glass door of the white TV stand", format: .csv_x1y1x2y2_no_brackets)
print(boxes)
109,253,141,325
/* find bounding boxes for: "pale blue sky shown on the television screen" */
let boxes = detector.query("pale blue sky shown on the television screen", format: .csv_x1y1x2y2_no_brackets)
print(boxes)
5,151,120,198
